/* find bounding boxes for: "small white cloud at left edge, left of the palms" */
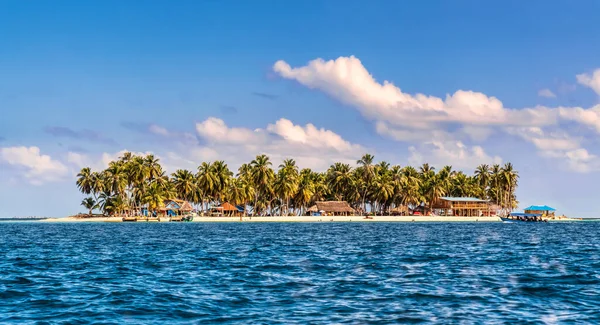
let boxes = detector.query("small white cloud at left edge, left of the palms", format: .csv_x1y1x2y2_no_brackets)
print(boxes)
0,147,68,185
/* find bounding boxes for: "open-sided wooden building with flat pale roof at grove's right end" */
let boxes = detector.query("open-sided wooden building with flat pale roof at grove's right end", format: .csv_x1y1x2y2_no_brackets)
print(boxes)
431,196,490,217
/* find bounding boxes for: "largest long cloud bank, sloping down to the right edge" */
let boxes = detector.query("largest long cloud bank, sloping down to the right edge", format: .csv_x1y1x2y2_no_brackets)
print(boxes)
273,56,600,170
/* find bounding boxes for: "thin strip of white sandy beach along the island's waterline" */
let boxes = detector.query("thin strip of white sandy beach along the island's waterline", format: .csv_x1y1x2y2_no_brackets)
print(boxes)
41,216,502,222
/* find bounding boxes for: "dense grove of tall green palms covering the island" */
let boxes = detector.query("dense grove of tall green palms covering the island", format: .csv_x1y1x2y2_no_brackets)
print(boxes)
77,153,519,215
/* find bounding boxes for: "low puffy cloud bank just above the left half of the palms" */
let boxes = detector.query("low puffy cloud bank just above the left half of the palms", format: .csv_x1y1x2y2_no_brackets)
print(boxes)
66,117,367,173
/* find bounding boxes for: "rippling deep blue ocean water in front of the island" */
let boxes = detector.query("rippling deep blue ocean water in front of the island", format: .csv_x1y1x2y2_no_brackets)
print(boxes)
0,222,600,324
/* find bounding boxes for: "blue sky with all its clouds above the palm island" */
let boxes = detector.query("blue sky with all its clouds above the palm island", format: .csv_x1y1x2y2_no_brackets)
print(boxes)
0,0,600,217
